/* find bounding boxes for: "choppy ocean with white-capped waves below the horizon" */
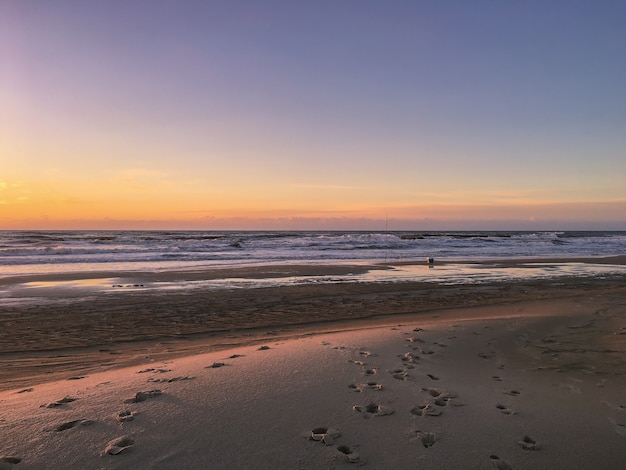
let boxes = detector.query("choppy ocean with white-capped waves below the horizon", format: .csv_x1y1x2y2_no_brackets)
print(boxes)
0,231,626,277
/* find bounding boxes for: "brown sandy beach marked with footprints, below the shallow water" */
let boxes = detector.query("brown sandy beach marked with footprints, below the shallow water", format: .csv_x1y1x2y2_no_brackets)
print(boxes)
0,258,626,470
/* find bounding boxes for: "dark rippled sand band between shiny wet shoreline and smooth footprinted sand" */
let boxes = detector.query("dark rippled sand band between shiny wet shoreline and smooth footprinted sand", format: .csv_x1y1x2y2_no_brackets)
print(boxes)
0,270,626,390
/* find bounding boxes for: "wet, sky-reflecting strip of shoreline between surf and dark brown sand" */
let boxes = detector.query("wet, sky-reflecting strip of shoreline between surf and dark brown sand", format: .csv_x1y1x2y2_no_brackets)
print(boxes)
0,255,626,306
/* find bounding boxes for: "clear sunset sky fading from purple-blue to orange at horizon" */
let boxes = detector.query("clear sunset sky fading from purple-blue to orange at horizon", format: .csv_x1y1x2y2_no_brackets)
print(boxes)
0,0,626,230
